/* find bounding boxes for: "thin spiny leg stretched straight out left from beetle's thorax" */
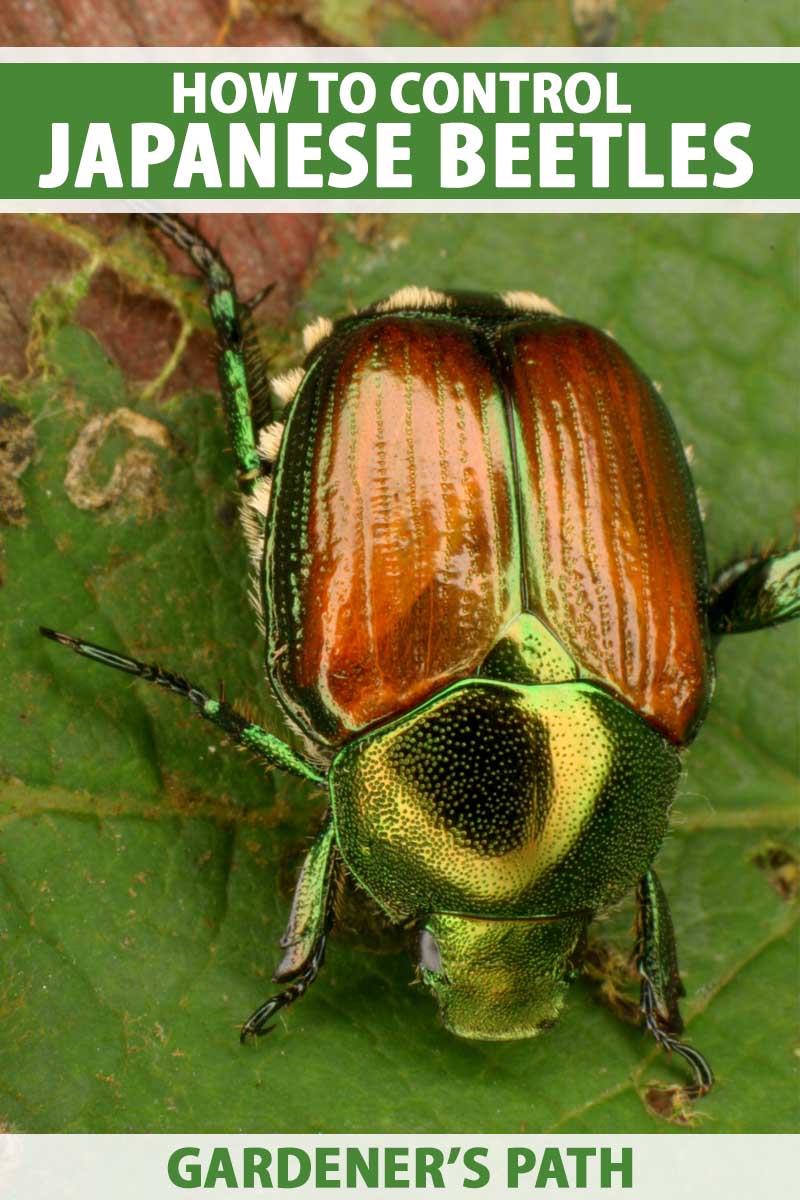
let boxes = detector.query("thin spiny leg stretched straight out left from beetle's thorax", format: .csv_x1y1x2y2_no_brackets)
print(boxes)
40,628,324,784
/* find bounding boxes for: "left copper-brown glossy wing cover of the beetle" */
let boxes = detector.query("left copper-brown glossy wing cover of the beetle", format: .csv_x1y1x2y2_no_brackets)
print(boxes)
266,317,518,744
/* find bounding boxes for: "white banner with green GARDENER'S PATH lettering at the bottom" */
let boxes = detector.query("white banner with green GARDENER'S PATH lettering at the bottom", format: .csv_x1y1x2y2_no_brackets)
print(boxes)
0,1133,800,1200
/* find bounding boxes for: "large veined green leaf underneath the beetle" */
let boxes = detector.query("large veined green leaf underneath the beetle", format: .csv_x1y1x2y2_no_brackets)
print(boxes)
0,206,798,1133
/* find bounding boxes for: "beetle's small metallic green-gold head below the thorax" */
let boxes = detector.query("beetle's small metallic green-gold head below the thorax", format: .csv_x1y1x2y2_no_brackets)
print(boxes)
420,913,588,1042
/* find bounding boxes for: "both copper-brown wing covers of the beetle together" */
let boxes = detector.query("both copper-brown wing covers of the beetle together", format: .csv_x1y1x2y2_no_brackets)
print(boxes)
265,314,710,745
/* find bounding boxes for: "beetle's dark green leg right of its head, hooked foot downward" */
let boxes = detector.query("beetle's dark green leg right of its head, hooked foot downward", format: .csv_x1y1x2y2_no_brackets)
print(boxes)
636,870,714,1097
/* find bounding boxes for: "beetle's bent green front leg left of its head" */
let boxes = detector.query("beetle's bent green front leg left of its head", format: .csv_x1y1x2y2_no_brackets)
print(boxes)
241,814,339,1042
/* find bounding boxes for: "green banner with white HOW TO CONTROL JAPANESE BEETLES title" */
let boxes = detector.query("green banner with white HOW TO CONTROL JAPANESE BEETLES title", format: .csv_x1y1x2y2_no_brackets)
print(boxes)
0,62,800,206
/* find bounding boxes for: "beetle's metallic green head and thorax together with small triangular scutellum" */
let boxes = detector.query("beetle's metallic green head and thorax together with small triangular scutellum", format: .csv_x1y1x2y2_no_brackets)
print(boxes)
329,676,680,1040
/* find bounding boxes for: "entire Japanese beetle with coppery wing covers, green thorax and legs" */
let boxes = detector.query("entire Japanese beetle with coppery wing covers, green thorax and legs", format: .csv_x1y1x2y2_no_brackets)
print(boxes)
42,216,800,1094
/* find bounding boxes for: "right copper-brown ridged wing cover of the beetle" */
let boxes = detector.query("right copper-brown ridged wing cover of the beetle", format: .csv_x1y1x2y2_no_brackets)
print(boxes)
498,319,712,743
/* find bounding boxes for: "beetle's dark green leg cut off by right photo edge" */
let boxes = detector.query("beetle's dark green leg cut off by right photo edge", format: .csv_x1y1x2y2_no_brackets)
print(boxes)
709,550,800,635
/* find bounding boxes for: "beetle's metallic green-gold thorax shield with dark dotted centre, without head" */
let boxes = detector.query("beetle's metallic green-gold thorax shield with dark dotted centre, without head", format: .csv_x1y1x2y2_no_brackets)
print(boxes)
330,679,679,919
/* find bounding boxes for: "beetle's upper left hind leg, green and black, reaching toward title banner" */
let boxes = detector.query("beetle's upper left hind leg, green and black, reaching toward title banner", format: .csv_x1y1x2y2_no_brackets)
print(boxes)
146,212,271,494
